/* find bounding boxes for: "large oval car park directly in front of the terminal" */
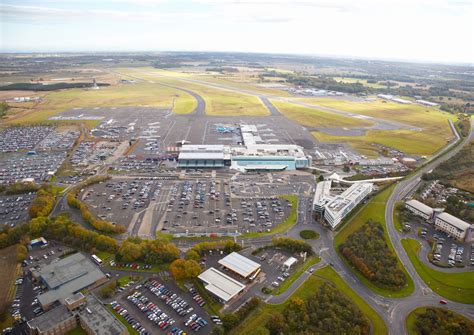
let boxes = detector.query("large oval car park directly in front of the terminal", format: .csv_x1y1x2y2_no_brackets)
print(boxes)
80,177,291,236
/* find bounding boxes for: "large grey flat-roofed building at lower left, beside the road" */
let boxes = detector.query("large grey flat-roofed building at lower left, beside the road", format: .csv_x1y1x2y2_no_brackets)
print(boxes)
31,253,107,310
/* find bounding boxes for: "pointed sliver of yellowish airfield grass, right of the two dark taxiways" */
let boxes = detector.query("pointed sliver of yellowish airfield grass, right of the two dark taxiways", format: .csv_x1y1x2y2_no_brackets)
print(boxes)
271,100,372,128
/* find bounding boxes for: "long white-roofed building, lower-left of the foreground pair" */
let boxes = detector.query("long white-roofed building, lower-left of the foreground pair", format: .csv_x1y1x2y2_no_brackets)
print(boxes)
198,267,245,303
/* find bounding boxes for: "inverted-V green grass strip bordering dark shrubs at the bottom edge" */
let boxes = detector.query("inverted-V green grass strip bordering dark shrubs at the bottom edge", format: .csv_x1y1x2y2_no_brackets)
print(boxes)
231,266,387,335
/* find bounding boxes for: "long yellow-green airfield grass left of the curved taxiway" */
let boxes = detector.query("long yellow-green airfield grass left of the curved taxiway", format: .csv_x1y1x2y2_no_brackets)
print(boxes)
10,83,197,123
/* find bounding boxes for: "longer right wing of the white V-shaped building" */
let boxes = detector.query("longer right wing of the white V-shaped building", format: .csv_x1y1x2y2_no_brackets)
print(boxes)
324,183,373,229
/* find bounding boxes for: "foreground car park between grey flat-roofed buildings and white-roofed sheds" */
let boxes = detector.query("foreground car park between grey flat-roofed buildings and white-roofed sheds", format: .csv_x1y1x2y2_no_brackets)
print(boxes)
111,278,212,335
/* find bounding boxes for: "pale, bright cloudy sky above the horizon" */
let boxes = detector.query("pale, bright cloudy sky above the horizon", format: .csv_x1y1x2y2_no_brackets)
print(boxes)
0,0,474,64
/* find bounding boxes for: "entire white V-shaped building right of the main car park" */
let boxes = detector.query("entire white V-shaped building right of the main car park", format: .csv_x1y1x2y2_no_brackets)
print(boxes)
313,181,373,229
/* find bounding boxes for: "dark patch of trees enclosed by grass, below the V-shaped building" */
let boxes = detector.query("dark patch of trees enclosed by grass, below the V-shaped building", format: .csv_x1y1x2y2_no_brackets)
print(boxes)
339,220,407,290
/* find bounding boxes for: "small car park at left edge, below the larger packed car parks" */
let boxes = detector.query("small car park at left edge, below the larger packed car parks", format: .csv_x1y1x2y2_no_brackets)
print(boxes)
0,192,36,227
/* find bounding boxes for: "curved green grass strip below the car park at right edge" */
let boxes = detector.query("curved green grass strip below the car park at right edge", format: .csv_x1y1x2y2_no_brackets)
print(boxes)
402,239,474,304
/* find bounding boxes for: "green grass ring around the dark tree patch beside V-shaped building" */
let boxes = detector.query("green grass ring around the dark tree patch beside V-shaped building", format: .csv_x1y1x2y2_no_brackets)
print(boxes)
334,185,415,298
